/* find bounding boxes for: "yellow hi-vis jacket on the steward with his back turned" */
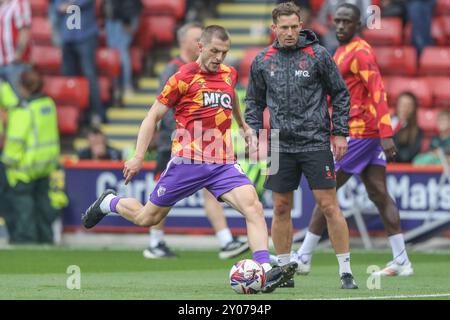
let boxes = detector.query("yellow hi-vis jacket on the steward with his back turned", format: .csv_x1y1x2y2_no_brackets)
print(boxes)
2,95,60,187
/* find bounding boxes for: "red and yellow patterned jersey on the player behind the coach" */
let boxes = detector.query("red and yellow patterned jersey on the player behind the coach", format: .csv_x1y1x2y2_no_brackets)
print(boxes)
334,37,393,138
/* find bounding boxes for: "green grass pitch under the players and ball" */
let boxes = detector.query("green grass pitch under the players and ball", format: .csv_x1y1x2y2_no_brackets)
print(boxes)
0,247,450,301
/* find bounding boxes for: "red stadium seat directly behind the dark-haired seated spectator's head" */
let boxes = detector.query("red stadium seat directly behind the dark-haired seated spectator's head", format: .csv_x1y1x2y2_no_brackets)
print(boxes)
384,77,433,108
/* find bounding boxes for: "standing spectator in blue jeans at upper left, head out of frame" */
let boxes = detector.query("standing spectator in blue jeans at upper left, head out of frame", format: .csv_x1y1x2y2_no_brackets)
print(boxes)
55,0,106,126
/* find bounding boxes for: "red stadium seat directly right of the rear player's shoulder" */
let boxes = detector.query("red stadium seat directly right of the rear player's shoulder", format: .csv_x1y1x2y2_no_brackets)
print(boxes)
373,47,417,76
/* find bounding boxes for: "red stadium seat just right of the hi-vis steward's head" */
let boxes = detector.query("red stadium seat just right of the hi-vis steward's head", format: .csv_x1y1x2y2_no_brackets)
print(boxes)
42,76,89,109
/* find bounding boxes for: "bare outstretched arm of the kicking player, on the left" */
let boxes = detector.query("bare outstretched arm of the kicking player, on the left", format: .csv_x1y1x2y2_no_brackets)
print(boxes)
123,100,169,184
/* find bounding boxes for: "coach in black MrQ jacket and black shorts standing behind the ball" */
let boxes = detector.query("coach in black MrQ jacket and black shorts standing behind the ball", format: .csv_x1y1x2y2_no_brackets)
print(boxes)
245,3,356,289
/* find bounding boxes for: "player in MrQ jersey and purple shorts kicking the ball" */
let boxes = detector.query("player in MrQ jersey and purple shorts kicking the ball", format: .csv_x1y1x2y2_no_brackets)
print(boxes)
82,25,297,293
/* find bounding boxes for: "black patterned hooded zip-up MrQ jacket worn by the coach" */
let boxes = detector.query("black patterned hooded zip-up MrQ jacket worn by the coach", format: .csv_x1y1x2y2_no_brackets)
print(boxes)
245,30,350,153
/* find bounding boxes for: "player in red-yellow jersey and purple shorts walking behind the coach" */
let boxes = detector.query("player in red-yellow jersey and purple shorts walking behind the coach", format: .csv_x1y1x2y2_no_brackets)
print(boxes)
293,4,413,276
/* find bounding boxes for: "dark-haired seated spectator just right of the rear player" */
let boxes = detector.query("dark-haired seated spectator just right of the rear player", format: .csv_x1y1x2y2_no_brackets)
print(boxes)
392,92,424,162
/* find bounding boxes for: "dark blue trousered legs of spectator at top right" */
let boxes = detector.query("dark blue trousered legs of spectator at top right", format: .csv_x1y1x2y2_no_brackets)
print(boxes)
406,0,436,56
